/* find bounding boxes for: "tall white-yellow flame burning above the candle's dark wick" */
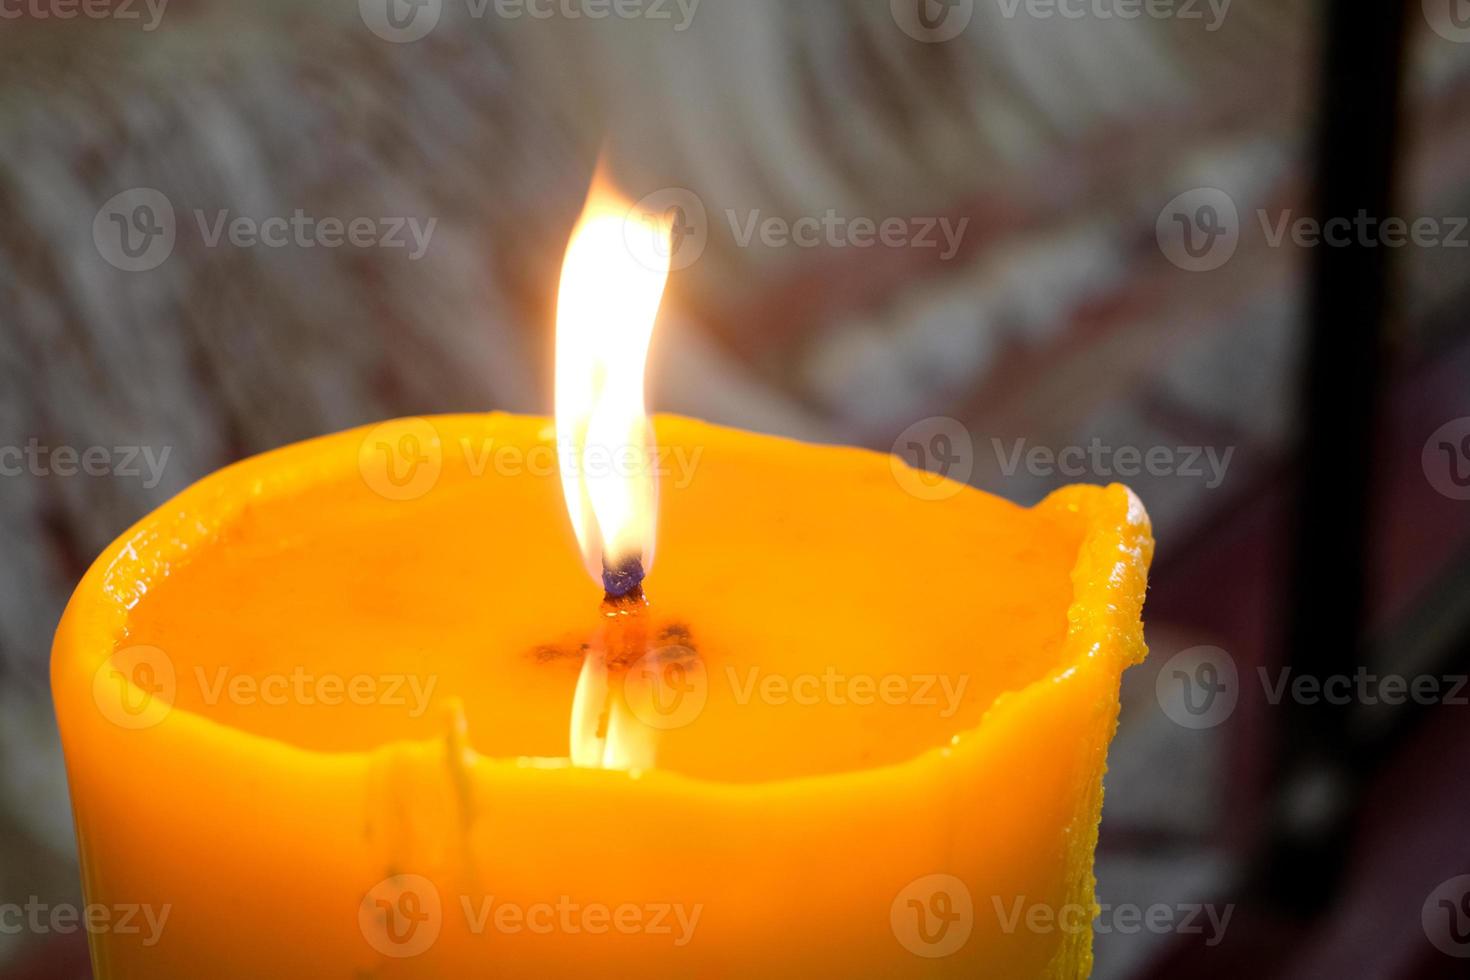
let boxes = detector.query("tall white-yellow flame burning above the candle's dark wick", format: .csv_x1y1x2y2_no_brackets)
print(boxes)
556,172,672,582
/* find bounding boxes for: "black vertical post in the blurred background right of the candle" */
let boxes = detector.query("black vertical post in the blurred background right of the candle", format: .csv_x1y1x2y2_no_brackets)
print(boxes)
1267,0,1419,915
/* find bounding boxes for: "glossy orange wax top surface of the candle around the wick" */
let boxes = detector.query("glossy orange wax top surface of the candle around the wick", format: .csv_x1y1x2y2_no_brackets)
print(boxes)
59,414,1151,783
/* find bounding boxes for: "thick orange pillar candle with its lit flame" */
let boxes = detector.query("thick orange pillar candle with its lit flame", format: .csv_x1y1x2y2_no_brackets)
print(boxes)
51,172,1152,979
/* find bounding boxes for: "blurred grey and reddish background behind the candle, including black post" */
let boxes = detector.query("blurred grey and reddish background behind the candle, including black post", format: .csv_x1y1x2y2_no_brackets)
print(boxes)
0,0,1470,977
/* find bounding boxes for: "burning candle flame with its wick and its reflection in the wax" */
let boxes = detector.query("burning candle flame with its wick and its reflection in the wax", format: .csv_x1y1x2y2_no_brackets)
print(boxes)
556,164,673,768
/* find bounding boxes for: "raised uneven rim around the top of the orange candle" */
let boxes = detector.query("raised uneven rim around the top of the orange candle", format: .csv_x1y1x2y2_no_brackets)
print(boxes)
51,411,1154,792
